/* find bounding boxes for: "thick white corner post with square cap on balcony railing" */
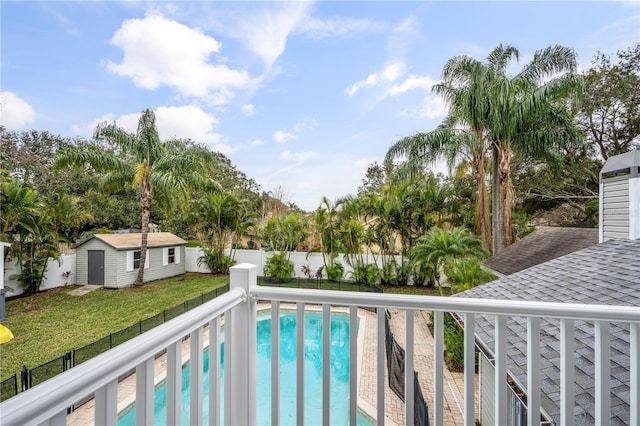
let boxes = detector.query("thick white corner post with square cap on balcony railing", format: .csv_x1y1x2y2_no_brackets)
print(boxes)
224,263,257,425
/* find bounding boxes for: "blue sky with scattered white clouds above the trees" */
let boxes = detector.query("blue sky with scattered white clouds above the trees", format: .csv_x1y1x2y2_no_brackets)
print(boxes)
0,0,640,210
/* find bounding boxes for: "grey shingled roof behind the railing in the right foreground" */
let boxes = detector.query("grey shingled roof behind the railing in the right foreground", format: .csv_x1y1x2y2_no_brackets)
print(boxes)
456,240,640,425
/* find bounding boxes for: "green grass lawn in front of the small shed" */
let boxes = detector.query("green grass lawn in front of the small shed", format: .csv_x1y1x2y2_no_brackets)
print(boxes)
0,273,229,379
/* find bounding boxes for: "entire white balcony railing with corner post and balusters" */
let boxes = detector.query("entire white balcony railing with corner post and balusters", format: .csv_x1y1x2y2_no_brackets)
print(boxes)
0,264,640,426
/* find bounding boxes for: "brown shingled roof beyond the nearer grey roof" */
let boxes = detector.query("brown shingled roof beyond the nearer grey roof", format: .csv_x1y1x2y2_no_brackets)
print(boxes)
484,226,598,275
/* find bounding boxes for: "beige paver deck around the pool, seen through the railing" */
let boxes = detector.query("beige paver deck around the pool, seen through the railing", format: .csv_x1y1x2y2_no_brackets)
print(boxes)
67,303,478,426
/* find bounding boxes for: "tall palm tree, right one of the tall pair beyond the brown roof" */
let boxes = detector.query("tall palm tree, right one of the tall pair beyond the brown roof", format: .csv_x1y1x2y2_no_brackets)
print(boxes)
487,46,583,250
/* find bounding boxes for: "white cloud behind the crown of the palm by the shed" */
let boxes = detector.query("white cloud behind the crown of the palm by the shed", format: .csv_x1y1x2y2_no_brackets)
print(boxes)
72,105,232,154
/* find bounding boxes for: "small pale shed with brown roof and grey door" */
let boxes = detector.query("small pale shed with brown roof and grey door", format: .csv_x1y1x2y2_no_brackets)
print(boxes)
76,232,187,288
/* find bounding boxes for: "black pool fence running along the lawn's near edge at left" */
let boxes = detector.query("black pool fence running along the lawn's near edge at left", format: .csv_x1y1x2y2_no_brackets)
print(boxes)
0,284,229,401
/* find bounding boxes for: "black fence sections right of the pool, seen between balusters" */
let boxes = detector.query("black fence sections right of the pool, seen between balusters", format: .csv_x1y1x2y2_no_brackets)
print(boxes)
384,311,429,426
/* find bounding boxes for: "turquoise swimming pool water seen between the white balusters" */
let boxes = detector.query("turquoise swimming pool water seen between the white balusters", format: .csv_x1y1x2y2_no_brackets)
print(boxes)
118,311,370,426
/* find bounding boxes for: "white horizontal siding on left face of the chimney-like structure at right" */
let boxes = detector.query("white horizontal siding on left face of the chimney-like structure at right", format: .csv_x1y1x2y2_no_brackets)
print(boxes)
601,179,629,241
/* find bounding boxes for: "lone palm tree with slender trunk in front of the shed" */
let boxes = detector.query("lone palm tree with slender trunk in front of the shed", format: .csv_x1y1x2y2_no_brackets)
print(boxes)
55,109,215,285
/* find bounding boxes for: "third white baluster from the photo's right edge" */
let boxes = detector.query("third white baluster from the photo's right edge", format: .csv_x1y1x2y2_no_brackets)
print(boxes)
560,318,575,426
